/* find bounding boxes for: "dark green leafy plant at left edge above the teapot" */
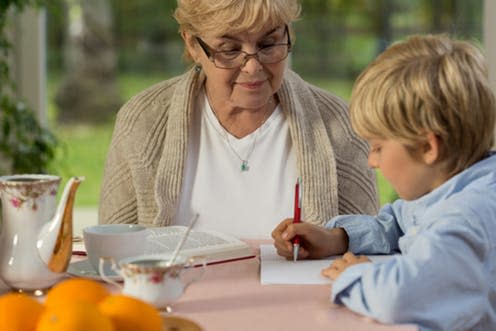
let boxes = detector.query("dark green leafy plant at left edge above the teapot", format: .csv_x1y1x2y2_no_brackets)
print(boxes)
0,0,57,175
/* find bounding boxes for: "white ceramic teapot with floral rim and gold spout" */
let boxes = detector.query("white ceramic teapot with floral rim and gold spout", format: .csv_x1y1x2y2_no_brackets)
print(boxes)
0,175,83,295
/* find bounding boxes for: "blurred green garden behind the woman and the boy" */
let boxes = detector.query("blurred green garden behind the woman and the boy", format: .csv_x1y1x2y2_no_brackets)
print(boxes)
3,0,484,214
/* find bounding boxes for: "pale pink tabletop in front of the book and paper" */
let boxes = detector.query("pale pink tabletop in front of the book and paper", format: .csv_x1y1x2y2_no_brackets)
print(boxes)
0,242,417,331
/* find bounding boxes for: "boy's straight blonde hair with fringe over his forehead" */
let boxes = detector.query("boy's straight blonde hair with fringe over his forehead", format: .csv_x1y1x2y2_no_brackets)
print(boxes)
350,35,495,174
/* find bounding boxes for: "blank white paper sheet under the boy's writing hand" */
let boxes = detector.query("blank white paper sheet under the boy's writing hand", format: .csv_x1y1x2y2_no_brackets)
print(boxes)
260,245,392,285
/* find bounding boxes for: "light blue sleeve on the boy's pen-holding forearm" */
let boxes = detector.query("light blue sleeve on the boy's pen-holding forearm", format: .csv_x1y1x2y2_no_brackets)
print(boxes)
326,200,403,254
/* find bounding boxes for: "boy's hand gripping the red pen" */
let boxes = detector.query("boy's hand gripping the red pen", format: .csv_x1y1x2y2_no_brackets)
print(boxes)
272,219,348,259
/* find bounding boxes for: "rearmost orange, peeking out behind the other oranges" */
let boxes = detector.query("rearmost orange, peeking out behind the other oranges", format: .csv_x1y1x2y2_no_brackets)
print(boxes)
45,278,110,307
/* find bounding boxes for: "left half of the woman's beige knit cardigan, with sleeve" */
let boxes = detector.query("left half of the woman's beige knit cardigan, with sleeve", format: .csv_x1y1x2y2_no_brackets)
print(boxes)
99,69,199,226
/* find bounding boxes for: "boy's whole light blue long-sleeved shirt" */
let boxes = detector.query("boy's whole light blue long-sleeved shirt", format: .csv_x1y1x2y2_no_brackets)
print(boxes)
326,154,496,331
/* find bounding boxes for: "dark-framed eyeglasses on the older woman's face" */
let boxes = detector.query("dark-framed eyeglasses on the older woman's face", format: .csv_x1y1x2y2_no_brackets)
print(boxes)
196,25,291,69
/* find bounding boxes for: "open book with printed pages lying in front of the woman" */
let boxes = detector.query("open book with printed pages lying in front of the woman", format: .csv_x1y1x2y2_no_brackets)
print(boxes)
145,225,256,264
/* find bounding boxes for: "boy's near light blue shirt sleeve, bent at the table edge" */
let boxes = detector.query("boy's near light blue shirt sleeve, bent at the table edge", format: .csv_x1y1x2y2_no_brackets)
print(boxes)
331,217,490,330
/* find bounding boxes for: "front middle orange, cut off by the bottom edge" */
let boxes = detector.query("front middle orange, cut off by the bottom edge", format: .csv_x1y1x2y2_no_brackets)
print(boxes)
36,301,114,331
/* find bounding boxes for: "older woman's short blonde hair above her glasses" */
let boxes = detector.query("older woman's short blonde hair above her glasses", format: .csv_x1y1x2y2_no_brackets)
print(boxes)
174,0,301,57
